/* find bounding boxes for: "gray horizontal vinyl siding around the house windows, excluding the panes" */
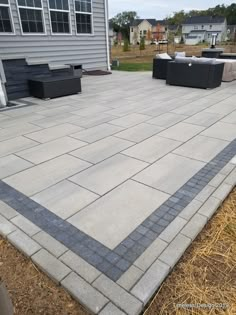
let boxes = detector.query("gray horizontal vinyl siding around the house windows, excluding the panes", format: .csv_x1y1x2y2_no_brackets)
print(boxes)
0,0,107,69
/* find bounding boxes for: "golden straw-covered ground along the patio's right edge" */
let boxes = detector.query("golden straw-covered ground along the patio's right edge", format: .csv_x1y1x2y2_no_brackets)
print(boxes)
145,189,236,315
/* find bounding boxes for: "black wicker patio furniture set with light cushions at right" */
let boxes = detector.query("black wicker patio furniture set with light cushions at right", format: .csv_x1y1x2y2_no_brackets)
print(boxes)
153,52,236,89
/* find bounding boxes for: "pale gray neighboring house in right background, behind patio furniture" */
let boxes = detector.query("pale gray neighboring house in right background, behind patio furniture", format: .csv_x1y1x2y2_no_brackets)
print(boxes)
182,16,227,45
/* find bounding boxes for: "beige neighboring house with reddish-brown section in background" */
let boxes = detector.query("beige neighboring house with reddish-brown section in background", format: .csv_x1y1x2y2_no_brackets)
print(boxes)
130,19,167,45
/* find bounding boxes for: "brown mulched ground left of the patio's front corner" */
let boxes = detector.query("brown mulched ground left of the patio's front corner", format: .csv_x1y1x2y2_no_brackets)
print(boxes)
0,238,88,315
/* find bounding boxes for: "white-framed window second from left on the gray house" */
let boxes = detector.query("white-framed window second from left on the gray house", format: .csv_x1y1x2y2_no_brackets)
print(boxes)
17,0,44,34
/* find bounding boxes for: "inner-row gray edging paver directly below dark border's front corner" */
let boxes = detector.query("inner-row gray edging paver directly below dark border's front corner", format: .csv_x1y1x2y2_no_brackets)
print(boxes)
93,275,142,315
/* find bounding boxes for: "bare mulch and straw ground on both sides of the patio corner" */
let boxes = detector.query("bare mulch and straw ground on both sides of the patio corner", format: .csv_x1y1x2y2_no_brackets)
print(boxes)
0,189,236,315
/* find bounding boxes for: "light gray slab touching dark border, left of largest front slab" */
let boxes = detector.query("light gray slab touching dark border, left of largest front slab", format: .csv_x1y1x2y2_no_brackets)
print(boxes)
32,180,99,219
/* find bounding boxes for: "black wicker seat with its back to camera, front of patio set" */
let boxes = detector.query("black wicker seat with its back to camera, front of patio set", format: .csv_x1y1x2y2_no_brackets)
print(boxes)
166,62,224,89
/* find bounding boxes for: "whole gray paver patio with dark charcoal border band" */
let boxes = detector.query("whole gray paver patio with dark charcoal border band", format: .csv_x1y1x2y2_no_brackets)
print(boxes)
0,72,236,315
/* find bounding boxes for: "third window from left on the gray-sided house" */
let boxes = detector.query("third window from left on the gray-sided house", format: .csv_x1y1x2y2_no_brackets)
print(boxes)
49,0,70,34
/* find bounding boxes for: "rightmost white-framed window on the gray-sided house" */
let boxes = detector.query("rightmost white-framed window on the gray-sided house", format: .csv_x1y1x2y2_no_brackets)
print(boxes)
75,0,92,34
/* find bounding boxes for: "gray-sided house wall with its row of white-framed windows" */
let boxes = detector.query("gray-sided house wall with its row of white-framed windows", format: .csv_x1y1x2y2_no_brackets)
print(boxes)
0,0,110,69
